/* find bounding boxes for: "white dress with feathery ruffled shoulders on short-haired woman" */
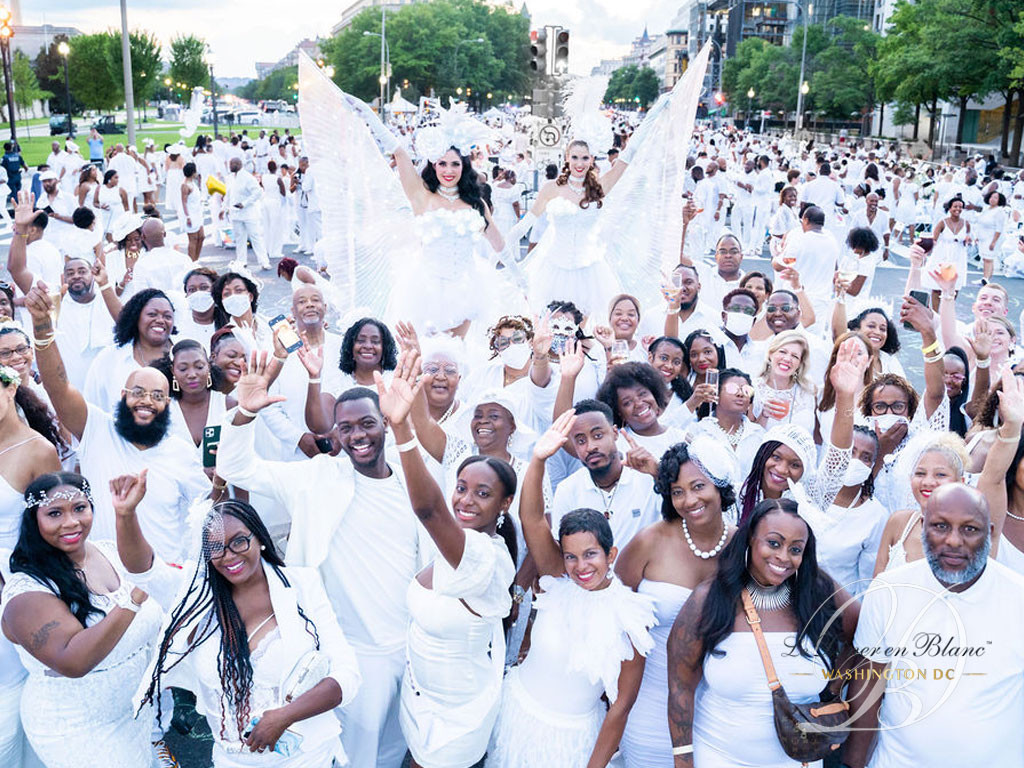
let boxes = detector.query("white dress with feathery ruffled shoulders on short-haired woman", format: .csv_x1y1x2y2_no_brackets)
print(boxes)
486,577,655,768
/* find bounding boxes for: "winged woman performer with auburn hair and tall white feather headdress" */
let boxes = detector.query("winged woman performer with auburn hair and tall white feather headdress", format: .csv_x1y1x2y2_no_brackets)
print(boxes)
508,45,709,316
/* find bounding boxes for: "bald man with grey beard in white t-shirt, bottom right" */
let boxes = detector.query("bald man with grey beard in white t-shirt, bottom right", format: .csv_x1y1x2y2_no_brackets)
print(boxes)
844,487,1024,768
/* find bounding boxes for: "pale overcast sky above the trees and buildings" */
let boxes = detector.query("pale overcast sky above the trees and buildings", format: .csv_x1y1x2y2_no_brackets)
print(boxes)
22,0,682,77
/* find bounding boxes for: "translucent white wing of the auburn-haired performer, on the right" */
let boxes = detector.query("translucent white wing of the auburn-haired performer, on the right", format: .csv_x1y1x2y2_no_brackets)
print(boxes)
596,43,711,303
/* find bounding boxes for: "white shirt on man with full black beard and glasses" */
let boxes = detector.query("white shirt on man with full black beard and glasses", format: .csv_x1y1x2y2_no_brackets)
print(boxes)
78,403,210,563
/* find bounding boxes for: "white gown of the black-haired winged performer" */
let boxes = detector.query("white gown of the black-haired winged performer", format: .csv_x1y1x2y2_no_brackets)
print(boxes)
388,208,497,333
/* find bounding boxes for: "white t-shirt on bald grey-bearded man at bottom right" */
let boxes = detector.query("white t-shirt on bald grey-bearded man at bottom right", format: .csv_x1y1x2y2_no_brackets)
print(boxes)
854,559,1024,768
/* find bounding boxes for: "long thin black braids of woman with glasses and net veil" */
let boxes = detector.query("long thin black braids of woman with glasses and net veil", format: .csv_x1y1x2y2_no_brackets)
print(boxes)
140,499,319,738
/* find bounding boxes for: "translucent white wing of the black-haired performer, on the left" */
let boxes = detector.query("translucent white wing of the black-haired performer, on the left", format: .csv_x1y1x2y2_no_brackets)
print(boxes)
299,53,419,317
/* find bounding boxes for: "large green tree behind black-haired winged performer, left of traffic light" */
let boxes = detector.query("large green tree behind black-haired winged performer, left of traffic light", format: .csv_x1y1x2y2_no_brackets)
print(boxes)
321,0,529,100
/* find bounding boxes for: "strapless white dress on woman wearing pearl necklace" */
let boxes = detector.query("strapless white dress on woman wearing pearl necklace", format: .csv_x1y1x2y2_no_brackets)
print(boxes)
621,579,692,768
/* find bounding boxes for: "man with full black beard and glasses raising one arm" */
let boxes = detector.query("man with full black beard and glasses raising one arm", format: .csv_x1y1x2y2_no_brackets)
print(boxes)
25,288,210,563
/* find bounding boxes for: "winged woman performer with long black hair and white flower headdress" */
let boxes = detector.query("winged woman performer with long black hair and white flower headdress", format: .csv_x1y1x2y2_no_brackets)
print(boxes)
299,56,516,331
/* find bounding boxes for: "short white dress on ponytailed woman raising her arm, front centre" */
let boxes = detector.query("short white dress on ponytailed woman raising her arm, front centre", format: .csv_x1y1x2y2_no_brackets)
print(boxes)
398,530,515,768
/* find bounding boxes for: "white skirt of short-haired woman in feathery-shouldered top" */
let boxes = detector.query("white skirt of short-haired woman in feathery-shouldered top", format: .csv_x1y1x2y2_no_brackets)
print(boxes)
485,668,604,768
